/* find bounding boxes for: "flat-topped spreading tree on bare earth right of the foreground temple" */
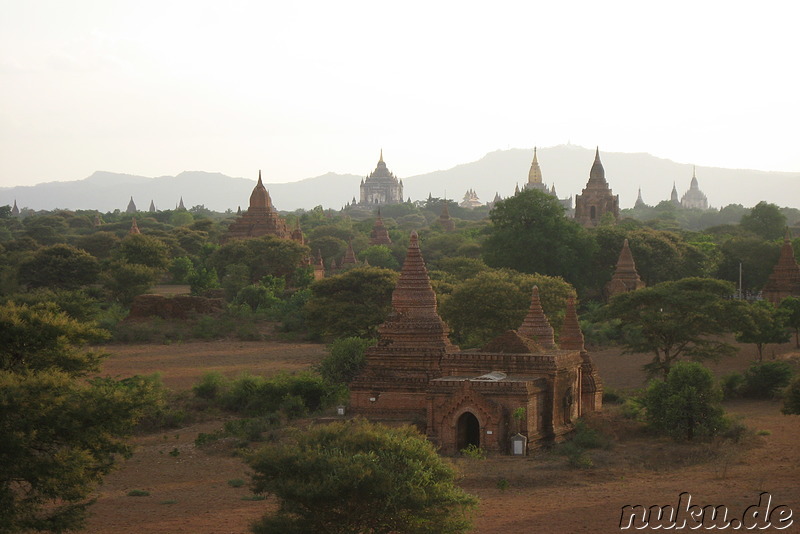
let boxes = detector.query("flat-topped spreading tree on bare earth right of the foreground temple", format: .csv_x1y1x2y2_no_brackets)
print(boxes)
606,278,740,377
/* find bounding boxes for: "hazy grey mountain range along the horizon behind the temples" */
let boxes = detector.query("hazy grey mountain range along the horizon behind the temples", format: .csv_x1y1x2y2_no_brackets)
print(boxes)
0,145,800,212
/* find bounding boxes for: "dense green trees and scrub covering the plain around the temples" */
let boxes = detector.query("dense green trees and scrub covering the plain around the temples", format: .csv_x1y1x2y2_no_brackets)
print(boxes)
0,196,800,531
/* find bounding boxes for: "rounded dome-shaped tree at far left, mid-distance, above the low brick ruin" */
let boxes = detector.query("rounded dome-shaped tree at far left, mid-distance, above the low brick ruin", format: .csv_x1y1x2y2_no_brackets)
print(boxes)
19,244,100,289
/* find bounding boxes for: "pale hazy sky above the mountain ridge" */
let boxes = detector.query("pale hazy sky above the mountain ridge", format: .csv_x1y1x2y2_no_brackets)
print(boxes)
0,0,800,191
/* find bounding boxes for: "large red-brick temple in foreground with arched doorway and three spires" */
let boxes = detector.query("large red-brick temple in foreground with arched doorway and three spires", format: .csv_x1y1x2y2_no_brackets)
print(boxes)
350,233,602,454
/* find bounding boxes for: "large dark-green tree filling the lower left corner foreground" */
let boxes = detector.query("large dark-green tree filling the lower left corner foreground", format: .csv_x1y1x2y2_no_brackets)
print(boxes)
0,304,160,533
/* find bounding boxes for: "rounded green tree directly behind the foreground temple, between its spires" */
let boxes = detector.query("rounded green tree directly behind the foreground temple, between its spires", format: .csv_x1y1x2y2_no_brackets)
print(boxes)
440,269,575,347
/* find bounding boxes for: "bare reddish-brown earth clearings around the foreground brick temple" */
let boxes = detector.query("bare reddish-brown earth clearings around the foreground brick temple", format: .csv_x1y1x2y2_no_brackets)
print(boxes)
87,341,800,534
